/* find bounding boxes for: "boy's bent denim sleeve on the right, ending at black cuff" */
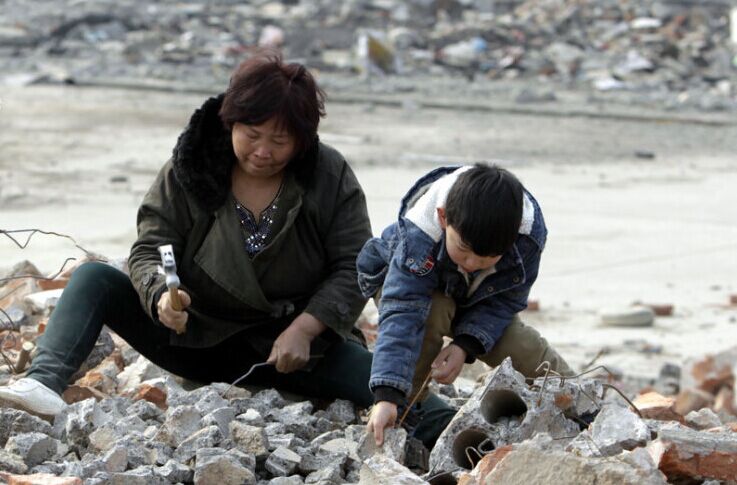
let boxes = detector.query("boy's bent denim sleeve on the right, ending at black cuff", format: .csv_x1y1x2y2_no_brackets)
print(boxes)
454,235,542,353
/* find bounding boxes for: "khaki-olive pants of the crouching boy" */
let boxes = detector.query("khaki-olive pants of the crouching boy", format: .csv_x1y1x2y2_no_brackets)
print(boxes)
412,291,573,399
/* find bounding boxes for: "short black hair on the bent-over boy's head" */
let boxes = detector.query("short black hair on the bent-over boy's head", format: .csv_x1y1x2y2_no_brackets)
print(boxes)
445,163,523,256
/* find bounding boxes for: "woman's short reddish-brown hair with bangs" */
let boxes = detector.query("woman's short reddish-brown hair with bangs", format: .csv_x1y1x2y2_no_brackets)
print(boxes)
219,49,325,156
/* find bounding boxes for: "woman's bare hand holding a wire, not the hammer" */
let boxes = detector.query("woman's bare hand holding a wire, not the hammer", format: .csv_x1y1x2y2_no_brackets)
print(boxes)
266,313,326,374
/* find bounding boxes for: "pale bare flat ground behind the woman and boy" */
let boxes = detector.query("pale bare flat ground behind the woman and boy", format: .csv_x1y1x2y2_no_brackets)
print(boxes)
0,86,737,377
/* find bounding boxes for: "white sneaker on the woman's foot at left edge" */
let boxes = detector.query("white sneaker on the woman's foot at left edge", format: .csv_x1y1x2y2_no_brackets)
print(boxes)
0,377,66,421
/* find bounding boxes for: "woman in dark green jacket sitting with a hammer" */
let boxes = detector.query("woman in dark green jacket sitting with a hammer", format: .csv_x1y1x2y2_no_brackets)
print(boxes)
0,52,454,445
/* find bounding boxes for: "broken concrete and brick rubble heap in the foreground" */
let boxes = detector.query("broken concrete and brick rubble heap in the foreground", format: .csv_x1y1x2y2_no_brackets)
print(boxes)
0,262,737,485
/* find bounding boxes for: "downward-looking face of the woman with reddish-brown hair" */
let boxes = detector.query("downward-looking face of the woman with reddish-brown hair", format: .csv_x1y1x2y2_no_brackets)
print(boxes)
232,118,296,178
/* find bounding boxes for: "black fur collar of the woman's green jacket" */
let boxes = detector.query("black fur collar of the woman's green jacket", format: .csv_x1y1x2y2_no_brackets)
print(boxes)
172,94,319,210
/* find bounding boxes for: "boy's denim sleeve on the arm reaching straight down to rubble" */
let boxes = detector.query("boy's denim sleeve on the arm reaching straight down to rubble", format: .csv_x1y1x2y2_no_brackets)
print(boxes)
369,222,438,395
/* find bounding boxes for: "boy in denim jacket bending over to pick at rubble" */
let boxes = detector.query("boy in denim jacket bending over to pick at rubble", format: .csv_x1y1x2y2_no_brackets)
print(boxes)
357,164,571,444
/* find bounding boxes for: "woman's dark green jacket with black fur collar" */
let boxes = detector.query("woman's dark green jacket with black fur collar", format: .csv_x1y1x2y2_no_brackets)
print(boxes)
129,95,371,353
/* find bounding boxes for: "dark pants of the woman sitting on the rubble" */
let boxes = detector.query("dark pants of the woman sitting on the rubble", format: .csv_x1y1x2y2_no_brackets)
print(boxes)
27,263,455,444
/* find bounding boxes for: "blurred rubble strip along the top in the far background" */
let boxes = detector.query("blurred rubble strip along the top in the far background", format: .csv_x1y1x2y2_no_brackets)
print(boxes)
0,0,737,109
